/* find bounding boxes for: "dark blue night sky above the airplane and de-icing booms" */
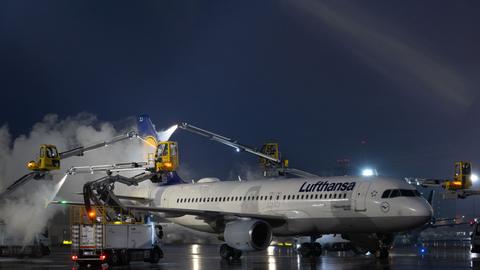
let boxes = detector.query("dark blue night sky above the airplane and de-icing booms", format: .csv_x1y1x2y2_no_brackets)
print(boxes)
0,0,480,181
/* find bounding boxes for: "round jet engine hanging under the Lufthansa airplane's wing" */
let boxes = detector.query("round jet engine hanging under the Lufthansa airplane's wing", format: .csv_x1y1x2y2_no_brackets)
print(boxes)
223,219,272,251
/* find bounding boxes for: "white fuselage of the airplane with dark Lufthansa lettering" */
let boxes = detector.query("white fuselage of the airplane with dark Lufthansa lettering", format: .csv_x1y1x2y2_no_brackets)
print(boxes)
124,176,432,236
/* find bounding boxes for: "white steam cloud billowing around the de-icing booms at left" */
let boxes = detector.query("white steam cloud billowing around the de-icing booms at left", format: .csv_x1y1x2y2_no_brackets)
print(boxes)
0,113,159,243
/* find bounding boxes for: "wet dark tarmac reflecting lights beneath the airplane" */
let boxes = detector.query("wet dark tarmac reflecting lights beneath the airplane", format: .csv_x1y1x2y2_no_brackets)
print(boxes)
0,245,480,270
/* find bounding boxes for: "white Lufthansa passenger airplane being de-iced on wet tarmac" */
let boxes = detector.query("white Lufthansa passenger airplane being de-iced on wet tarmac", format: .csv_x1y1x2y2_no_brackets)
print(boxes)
58,115,433,259
